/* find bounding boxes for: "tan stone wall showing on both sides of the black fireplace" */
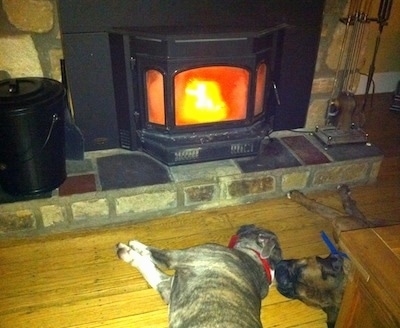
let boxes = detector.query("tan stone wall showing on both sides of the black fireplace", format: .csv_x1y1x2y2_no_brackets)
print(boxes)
0,0,368,133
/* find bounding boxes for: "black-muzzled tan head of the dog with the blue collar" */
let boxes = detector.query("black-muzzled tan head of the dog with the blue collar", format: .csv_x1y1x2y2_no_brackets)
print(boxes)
275,254,348,327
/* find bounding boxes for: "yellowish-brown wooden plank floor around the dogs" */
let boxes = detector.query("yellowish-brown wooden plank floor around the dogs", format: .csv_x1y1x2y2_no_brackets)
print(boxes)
0,93,400,328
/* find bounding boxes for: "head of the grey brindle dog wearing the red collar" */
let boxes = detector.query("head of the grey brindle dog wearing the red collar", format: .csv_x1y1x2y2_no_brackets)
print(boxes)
236,224,282,269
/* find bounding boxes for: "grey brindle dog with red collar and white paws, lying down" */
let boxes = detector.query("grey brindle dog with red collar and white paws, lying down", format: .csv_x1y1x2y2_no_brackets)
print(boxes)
117,225,282,328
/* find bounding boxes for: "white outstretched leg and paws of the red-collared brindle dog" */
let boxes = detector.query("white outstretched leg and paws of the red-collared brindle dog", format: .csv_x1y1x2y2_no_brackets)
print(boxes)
117,240,172,304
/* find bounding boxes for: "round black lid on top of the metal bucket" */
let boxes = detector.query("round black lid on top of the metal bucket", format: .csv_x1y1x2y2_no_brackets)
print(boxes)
0,77,65,110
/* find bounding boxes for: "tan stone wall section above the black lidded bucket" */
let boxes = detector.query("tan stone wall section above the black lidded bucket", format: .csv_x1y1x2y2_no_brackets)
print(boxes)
0,0,63,81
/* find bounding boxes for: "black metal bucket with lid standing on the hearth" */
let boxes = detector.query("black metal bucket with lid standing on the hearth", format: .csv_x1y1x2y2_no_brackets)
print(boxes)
0,78,66,195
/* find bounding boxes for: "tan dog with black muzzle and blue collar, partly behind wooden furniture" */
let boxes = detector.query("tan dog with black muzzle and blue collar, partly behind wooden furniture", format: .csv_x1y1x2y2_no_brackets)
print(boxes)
276,185,387,328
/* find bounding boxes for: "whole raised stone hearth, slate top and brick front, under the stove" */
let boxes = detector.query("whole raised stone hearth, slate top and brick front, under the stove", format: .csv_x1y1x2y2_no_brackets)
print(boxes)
0,131,383,237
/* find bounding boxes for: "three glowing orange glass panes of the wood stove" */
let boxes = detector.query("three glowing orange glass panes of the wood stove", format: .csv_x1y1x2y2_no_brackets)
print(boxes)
146,63,267,126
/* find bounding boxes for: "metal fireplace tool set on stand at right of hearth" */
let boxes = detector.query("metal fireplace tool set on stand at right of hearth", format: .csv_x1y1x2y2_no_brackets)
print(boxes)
315,0,393,146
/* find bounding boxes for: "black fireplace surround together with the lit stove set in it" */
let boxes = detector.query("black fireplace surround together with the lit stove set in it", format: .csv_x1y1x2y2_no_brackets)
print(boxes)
58,0,324,165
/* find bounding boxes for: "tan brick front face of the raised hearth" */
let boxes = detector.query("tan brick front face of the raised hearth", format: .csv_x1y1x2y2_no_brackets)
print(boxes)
0,132,383,238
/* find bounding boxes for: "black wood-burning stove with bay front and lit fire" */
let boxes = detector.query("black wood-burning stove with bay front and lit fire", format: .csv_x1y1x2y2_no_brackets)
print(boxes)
115,25,285,165
